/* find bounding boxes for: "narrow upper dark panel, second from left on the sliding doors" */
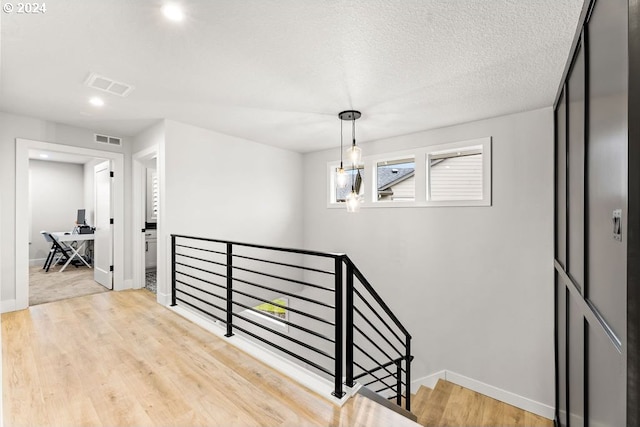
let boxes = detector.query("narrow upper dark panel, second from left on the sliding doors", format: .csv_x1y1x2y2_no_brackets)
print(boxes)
566,45,585,290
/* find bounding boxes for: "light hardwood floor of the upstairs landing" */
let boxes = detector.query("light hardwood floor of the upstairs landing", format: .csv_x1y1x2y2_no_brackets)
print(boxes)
2,290,416,427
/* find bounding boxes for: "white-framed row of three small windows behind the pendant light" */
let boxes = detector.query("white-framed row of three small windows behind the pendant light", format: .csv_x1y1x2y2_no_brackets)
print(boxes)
327,137,491,208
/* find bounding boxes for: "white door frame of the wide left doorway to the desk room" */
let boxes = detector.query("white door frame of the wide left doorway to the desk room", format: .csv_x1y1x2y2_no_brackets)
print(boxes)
15,138,125,310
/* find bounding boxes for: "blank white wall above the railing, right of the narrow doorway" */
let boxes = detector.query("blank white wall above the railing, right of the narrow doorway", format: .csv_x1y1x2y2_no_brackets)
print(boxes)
158,120,303,301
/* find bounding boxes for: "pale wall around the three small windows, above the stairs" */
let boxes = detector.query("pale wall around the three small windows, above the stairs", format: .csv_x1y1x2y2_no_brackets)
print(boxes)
304,108,554,406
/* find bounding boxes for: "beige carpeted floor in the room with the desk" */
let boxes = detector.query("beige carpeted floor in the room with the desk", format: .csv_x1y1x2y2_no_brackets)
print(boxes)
29,265,108,305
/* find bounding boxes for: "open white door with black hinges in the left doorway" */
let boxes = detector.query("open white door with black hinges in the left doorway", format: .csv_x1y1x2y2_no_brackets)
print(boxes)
93,161,113,289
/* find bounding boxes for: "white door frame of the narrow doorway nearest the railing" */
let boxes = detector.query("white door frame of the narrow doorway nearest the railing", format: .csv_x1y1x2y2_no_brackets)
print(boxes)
132,145,162,289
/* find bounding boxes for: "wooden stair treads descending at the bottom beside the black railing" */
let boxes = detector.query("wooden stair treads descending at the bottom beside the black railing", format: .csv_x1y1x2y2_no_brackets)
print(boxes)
411,380,553,427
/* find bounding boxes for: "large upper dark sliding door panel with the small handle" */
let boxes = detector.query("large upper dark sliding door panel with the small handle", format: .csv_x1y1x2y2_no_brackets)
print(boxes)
587,0,628,346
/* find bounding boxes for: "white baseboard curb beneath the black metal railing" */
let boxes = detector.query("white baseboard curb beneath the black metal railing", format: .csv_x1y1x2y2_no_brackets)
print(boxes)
168,306,358,406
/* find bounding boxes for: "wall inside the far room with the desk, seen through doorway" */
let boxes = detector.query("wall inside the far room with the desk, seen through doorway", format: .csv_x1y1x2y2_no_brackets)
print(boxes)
29,160,85,265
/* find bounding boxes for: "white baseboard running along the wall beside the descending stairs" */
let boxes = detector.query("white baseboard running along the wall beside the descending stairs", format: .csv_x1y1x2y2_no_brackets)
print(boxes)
411,370,555,420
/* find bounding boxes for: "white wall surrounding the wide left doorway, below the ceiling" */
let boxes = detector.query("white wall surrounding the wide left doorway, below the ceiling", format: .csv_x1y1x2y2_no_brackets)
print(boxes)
0,112,131,310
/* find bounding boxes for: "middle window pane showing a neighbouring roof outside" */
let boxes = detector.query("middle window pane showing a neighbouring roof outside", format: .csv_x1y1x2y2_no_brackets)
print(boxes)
376,157,416,202
